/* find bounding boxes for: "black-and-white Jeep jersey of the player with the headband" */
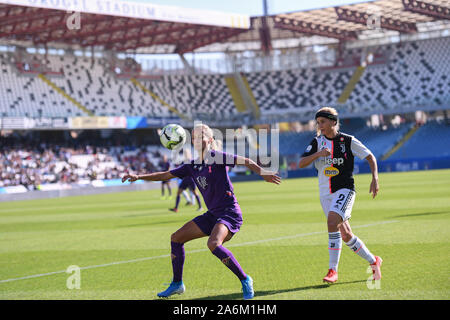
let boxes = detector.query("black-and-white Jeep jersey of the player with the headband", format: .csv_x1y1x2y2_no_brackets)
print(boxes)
302,132,371,195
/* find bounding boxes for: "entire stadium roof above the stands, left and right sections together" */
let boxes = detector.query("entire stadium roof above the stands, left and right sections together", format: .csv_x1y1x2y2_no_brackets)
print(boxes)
0,0,450,53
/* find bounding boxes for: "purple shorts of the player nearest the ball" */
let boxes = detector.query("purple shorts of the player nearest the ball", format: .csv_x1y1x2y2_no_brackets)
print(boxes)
192,209,242,236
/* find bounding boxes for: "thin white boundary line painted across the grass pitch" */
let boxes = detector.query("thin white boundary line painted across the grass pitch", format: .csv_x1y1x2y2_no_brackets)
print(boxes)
0,220,398,283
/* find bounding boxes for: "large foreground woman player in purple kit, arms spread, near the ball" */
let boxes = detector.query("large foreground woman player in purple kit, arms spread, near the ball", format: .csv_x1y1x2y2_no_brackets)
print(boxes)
122,124,281,299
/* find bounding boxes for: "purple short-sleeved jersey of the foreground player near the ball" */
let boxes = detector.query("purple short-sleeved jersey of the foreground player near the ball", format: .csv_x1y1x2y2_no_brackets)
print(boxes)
170,150,241,215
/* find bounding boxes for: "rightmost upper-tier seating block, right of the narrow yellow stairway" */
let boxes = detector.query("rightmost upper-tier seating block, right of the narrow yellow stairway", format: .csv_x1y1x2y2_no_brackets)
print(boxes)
348,38,450,115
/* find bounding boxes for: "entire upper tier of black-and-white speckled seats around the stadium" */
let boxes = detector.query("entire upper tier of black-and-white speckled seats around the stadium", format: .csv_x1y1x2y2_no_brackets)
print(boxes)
0,38,450,118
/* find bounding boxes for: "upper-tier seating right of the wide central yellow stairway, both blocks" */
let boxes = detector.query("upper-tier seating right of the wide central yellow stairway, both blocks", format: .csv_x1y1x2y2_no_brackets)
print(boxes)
246,38,450,113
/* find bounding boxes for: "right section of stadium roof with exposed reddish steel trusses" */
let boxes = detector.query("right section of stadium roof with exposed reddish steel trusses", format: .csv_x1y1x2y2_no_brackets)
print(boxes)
203,0,450,51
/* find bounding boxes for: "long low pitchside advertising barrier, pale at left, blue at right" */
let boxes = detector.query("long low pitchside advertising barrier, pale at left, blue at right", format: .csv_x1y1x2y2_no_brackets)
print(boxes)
0,157,450,202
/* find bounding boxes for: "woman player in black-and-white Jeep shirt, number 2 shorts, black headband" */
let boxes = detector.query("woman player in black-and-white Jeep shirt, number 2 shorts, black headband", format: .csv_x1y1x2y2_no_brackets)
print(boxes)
299,107,383,283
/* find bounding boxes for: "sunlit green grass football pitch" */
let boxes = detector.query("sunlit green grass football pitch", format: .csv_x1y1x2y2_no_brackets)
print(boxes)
0,170,450,300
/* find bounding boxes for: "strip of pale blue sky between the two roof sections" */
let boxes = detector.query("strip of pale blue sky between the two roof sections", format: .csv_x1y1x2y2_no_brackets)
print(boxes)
123,0,370,16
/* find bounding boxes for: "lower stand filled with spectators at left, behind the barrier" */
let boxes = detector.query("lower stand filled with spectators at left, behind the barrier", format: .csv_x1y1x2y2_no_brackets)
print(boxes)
0,139,171,190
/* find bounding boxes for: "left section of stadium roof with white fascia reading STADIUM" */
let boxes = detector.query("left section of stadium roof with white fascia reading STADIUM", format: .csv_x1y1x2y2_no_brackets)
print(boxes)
0,0,250,53
